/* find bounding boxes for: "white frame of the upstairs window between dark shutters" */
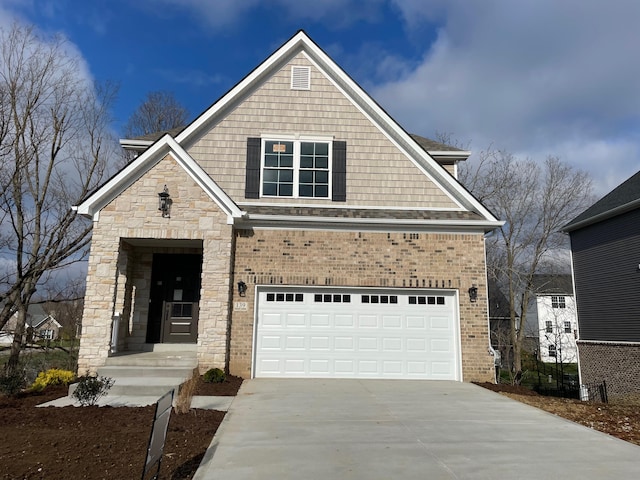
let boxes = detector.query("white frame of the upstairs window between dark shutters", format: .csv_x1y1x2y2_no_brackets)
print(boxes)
260,134,333,200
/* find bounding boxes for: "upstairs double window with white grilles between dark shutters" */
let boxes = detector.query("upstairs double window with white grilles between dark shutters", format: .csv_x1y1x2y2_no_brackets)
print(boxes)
262,139,331,198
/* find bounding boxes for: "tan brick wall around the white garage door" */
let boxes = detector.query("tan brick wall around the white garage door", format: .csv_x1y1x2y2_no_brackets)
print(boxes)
229,230,494,382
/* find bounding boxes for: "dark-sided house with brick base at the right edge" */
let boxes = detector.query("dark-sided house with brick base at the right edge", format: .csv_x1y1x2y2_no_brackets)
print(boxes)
563,172,640,395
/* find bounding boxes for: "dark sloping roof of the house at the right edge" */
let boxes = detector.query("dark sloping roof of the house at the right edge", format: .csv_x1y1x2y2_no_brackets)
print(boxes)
562,171,640,232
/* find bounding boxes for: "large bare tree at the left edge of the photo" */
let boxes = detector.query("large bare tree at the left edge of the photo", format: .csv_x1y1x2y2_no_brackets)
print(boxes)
0,23,116,370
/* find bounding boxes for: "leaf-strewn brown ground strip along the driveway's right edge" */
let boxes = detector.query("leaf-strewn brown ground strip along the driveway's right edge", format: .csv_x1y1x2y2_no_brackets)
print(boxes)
480,383,640,445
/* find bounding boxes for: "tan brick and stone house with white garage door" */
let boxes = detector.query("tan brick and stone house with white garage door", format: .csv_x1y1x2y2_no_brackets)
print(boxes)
75,32,501,381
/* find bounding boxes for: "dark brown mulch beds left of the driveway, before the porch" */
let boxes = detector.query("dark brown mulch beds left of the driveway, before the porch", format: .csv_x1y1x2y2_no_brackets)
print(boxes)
0,377,242,480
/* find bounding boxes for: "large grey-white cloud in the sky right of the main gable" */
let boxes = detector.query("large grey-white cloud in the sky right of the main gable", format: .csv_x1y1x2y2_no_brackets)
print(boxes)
371,0,640,193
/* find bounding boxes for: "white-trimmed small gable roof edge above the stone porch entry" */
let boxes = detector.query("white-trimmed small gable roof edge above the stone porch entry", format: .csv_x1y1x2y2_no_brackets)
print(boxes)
73,134,243,223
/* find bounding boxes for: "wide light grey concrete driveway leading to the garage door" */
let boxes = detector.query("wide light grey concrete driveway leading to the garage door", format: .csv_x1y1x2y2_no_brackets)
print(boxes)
194,379,640,480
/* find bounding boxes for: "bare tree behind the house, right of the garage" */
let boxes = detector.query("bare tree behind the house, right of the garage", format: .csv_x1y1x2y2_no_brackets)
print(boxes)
460,149,593,378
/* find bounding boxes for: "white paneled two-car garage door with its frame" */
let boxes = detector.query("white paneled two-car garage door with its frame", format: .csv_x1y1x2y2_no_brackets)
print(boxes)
251,285,462,381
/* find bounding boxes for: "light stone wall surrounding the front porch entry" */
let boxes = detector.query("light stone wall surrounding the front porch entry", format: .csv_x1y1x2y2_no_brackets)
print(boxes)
78,156,233,373
